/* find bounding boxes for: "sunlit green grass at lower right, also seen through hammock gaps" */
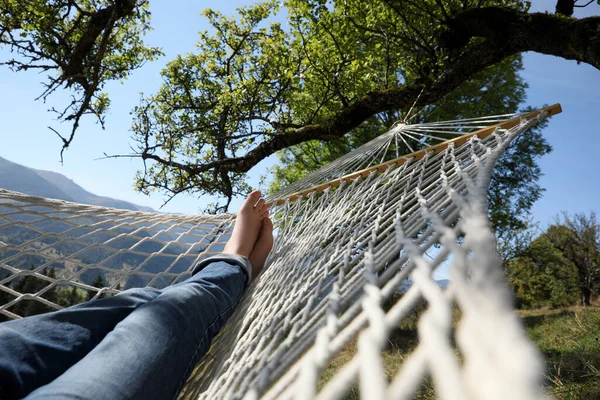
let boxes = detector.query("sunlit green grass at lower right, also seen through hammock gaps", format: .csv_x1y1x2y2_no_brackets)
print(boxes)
319,299,600,400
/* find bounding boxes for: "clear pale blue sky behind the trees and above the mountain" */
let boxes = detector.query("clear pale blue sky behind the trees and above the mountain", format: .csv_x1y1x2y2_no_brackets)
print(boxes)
0,0,600,228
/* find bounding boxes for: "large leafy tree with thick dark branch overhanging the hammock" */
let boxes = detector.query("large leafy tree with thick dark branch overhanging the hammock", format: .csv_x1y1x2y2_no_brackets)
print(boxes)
125,0,600,208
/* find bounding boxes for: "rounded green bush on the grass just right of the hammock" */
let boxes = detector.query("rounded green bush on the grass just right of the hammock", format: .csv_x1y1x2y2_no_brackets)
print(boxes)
506,234,579,308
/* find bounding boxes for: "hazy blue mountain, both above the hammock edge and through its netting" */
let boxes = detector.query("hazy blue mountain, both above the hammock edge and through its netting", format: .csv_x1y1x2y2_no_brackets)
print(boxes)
0,158,201,288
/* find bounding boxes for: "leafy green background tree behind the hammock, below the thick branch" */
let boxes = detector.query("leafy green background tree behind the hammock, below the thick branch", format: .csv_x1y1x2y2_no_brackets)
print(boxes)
268,57,551,242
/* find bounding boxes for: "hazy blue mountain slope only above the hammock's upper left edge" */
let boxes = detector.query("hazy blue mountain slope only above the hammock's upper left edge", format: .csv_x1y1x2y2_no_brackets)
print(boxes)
0,157,154,211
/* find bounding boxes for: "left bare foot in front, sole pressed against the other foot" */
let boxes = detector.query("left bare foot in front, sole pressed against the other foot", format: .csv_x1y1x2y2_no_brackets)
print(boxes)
223,190,268,257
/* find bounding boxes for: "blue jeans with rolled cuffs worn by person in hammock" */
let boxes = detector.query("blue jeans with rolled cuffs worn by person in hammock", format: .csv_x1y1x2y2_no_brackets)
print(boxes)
0,255,251,400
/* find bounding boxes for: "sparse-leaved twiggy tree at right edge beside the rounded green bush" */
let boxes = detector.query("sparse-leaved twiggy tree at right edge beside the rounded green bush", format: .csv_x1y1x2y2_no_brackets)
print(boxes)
546,212,600,306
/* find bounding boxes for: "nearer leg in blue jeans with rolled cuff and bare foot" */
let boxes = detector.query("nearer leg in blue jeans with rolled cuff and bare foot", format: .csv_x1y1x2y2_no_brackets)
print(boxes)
28,191,272,399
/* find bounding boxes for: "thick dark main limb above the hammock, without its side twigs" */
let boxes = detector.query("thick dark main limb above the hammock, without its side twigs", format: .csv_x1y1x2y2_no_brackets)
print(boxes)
171,7,600,172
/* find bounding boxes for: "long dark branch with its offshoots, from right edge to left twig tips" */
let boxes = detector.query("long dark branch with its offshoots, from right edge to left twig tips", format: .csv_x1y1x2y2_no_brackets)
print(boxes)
132,1,600,209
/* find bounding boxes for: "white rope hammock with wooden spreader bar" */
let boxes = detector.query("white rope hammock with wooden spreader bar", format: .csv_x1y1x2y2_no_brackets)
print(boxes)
0,105,560,399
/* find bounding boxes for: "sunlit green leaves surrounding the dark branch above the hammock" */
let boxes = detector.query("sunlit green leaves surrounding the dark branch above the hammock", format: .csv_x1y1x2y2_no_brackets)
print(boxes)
127,0,548,211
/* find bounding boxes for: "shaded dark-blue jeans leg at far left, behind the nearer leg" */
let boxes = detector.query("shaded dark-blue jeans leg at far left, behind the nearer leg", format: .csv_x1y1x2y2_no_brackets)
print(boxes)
0,288,160,399
